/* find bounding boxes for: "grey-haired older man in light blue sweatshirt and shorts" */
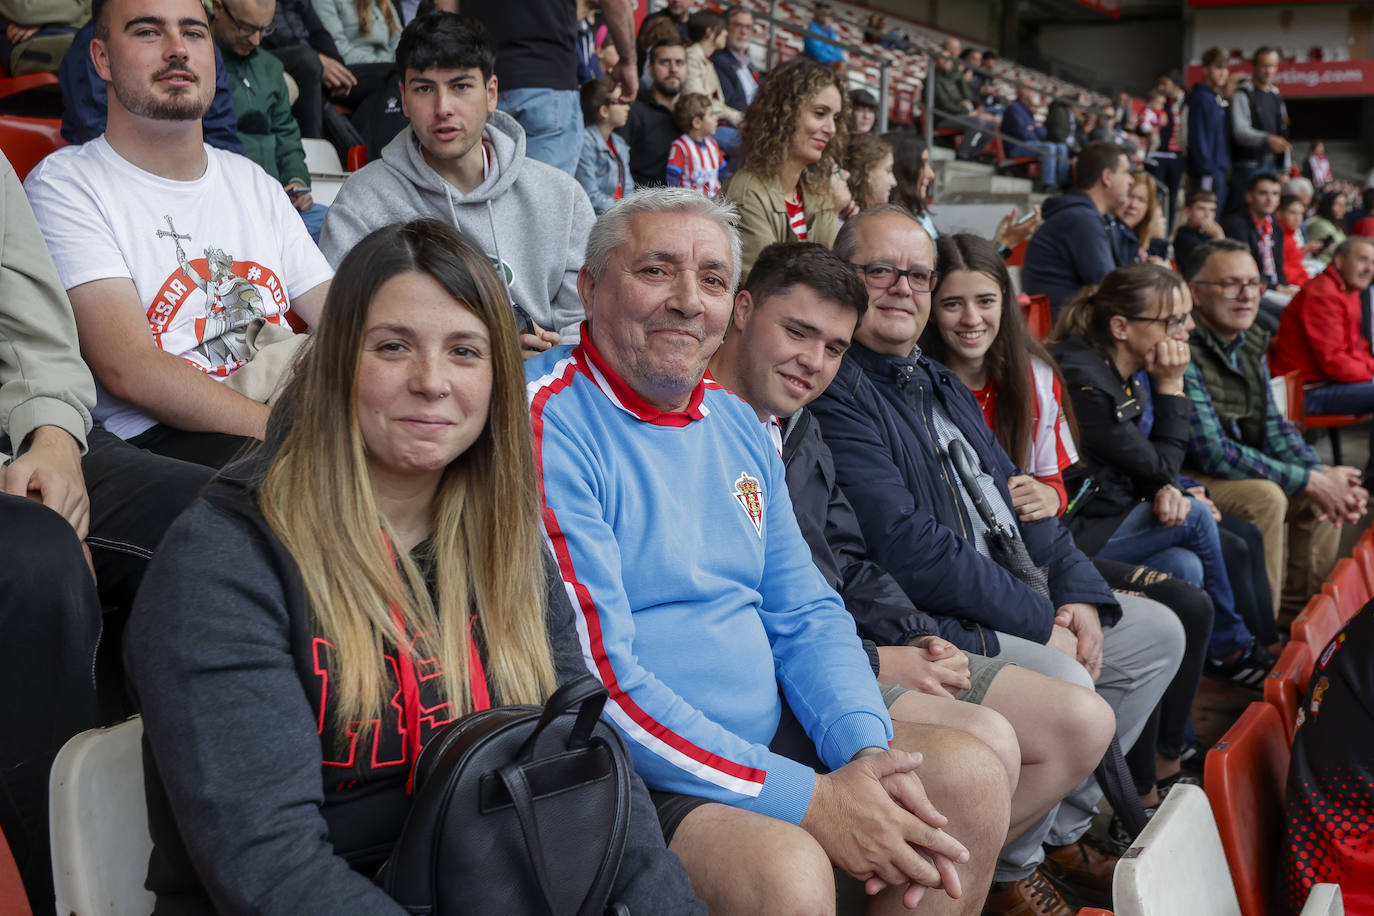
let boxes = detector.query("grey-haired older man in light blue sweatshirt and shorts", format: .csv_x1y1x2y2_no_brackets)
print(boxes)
526,188,1009,913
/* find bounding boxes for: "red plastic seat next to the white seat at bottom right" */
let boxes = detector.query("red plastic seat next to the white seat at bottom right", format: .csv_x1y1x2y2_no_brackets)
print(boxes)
1202,703,1289,916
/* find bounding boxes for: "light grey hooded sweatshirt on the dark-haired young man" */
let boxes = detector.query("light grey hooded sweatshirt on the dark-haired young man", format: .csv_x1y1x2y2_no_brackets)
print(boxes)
320,111,596,343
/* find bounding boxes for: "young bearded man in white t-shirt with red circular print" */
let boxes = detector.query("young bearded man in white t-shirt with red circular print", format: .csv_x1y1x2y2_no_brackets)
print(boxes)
25,0,331,477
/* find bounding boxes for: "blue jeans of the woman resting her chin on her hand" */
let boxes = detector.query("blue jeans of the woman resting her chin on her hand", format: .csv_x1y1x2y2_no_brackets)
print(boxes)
1098,497,1254,658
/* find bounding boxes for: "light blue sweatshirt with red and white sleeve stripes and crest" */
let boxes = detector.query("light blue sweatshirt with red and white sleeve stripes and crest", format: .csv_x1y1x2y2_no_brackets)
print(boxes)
525,330,892,823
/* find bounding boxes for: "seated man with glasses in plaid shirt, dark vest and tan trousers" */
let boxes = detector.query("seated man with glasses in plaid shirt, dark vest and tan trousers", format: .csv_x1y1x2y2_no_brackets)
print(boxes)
1183,239,1369,615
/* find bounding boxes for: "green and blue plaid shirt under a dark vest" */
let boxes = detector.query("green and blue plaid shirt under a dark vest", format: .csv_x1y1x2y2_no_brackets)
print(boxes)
1183,347,1322,496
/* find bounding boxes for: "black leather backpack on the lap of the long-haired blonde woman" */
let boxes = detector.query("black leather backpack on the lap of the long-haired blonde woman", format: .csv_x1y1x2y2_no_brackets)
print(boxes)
379,676,631,916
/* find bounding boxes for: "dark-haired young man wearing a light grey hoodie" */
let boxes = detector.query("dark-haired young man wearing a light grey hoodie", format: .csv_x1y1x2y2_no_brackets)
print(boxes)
320,12,596,356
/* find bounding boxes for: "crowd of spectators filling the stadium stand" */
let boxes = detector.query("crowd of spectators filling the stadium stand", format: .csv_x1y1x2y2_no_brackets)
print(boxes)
0,0,1374,916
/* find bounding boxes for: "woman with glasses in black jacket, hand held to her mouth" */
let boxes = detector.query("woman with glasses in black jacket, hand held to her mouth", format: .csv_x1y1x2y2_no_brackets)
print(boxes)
1050,264,1274,685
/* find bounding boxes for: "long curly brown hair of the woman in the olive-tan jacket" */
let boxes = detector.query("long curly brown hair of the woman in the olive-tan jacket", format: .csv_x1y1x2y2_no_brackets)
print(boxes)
739,58,849,196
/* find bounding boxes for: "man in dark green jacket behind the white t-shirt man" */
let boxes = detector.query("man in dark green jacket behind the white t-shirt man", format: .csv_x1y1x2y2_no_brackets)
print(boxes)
210,0,327,242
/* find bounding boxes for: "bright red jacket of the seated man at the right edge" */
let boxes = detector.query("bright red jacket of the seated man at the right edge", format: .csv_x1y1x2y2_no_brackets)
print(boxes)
1270,266,1374,383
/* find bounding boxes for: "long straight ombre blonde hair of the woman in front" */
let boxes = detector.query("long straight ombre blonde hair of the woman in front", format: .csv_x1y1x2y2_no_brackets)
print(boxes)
261,220,554,737
